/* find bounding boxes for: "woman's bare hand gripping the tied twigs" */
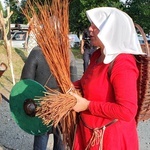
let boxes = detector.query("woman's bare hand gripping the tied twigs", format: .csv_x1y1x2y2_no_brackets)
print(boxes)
70,92,90,112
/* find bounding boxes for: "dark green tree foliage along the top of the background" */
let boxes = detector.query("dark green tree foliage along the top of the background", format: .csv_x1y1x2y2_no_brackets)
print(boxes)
3,0,150,34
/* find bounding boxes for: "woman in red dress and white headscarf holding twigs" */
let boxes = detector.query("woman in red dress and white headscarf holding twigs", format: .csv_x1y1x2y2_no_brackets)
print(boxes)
71,7,143,150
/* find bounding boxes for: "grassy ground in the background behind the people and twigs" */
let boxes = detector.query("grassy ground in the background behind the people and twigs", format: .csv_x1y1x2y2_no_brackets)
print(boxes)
0,44,82,98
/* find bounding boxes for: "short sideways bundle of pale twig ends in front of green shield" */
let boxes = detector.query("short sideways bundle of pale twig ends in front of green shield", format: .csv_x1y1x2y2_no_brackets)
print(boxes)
36,89,77,126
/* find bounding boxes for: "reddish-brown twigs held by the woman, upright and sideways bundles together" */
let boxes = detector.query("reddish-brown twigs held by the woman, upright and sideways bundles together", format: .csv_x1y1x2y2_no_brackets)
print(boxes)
22,0,79,148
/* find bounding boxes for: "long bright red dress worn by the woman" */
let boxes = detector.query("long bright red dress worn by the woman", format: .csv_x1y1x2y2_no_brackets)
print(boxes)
74,50,139,150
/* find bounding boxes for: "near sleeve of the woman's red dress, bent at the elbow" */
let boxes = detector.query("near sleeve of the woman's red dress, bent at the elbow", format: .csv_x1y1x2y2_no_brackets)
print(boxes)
89,55,138,121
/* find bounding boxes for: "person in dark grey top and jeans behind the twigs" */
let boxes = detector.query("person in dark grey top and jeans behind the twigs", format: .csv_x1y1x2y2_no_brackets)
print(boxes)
21,46,77,150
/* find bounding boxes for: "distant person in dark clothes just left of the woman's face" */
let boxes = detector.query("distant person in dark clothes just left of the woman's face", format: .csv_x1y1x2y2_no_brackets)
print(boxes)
81,29,96,72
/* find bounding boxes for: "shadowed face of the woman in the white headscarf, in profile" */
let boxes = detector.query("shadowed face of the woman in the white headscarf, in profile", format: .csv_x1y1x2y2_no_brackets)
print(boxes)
89,23,104,49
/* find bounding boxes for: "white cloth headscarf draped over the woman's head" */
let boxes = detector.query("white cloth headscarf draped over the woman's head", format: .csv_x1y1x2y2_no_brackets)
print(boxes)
86,7,144,64
